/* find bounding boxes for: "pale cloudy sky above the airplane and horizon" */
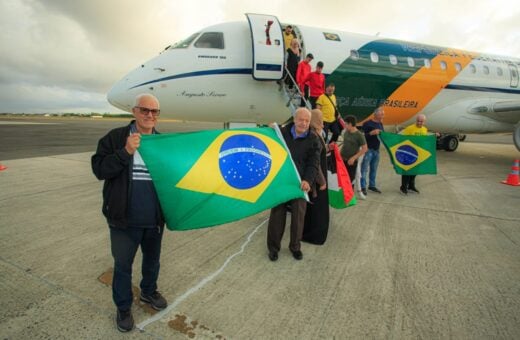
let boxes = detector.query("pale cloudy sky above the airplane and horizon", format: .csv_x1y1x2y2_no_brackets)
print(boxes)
0,0,520,113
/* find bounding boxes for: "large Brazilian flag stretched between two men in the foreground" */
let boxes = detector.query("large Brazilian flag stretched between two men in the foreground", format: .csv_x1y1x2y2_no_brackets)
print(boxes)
139,128,305,230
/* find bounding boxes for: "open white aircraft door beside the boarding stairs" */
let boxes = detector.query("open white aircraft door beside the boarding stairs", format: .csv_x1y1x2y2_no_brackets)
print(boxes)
246,13,285,80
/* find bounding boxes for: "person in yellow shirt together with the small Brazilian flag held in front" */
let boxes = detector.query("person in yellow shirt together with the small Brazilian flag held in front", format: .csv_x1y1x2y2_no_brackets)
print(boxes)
379,114,437,195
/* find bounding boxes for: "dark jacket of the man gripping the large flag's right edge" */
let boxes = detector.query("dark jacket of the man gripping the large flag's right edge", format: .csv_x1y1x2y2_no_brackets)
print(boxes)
281,123,321,187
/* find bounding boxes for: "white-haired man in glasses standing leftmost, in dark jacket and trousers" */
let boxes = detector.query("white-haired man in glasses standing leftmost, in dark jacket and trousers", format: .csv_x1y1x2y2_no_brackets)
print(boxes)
91,94,168,332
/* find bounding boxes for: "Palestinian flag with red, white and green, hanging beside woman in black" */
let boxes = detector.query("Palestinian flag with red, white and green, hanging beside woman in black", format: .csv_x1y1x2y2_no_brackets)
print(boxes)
327,143,356,209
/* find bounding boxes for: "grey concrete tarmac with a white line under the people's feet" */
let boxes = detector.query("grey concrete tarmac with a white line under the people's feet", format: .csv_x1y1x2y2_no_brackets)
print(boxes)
0,118,520,339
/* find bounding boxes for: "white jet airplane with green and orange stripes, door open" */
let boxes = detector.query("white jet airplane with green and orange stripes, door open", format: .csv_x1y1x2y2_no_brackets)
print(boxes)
107,13,520,151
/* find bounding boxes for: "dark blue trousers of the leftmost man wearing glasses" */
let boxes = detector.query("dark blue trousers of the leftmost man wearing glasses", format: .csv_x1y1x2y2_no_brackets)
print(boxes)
110,227,164,310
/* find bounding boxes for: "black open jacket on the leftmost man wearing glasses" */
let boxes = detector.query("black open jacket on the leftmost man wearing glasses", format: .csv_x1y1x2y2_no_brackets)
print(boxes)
91,121,164,228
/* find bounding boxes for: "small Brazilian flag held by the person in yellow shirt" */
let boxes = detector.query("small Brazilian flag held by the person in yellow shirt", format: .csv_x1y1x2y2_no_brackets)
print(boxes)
379,132,437,175
